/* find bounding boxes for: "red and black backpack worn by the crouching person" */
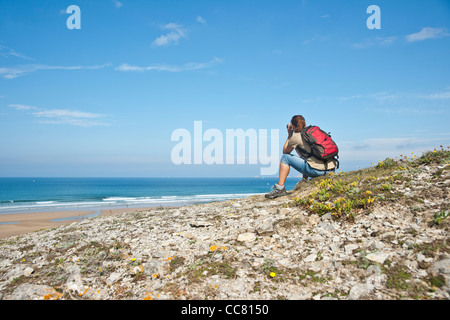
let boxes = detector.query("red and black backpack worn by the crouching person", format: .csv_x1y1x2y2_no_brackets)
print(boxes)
301,126,339,167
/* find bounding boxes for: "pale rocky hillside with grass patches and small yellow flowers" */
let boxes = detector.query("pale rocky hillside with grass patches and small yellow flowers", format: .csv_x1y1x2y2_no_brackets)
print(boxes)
0,149,450,300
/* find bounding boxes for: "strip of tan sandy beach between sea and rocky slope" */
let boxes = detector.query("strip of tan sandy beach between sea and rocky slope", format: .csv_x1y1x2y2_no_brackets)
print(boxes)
0,207,155,239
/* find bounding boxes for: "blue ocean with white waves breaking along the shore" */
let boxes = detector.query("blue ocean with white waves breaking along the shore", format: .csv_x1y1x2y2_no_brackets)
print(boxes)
0,177,299,214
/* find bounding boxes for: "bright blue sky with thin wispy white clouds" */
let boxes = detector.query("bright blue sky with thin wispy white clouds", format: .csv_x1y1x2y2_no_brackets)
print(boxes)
0,0,450,177
